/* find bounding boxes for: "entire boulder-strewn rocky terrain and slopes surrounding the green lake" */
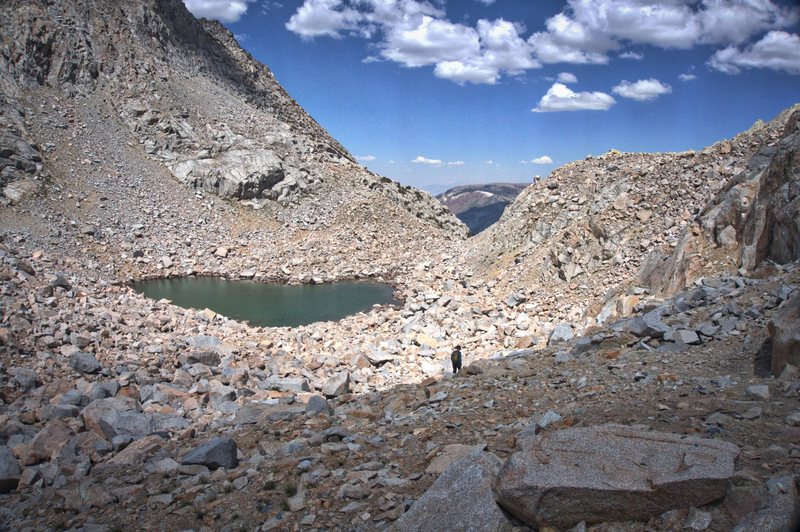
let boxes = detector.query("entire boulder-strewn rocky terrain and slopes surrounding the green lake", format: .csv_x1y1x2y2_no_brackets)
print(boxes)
0,1,800,531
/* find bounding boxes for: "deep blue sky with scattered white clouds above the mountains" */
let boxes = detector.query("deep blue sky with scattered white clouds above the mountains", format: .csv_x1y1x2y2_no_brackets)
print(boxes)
185,0,800,193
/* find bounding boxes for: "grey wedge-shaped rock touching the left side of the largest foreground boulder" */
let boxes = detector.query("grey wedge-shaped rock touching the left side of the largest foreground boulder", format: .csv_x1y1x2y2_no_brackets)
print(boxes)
389,450,513,532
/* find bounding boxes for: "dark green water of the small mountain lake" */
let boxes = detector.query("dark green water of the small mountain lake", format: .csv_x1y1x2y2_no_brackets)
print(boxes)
131,277,398,327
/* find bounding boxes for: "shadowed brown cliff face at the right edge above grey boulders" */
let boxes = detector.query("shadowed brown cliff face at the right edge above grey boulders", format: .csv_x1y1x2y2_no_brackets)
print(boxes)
641,110,800,294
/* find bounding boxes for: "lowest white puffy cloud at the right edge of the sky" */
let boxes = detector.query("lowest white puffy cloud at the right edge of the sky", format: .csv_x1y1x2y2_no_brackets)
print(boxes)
708,31,800,74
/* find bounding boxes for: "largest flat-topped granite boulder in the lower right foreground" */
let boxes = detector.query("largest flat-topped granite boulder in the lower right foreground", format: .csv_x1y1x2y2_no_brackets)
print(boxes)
495,425,739,529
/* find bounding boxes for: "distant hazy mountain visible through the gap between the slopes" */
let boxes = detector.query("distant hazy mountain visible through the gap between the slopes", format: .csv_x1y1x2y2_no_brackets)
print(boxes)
436,183,529,235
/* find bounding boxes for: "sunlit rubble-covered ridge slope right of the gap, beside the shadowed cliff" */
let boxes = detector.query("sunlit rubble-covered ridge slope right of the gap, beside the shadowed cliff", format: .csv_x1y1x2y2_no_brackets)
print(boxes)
467,111,793,340
